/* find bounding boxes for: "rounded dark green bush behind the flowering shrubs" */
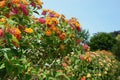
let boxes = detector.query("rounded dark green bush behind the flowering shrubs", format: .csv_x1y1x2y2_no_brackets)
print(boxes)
89,32,116,51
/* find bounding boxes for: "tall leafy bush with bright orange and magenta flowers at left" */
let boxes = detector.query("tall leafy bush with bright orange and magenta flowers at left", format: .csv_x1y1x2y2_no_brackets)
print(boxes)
0,0,83,79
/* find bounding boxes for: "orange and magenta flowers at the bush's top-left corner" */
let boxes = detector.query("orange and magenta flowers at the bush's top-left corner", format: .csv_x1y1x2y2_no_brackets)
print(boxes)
0,0,43,17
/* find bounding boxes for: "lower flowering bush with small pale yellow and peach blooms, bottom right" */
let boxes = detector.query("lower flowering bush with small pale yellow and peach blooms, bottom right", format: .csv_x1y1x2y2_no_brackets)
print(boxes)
30,50,120,80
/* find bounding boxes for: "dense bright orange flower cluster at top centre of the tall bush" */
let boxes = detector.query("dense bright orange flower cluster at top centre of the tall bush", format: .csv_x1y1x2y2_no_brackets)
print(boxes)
39,10,66,40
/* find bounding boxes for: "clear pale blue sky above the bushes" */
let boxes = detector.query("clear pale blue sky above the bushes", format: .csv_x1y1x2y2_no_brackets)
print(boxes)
42,0,120,35
